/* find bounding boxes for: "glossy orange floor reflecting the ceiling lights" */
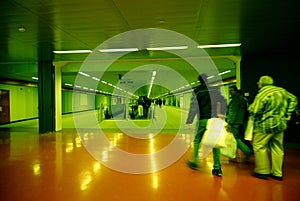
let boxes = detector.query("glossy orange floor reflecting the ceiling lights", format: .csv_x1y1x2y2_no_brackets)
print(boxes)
0,129,300,201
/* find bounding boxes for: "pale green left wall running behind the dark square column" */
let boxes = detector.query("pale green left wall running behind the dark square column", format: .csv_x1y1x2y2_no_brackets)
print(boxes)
0,84,111,122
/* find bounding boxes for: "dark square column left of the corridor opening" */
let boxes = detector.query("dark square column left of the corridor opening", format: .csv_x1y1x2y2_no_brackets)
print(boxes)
38,61,55,133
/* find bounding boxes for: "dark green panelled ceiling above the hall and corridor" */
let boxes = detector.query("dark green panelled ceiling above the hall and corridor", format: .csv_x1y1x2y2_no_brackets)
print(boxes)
0,0,300,96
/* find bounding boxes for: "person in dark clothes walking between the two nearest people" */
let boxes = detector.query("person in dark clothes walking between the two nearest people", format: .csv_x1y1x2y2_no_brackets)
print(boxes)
225,85,252,161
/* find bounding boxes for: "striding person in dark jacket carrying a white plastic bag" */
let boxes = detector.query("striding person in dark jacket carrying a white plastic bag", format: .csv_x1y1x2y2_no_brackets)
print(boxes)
186,74,226,177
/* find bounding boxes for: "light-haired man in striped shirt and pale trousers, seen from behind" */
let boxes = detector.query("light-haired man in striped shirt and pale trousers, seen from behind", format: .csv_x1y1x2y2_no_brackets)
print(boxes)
249,76,298,181
